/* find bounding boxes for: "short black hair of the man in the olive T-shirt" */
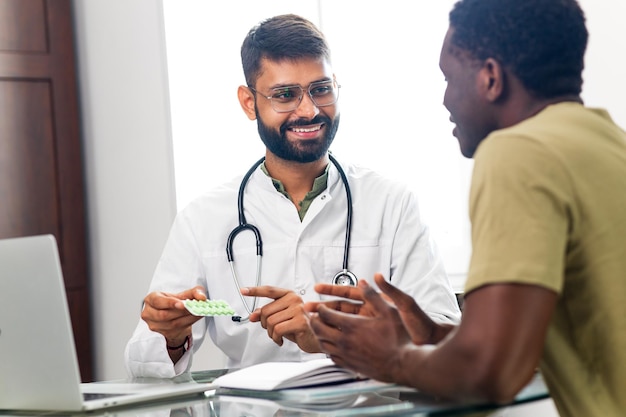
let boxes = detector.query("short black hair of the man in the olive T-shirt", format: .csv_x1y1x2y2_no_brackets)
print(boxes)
450,0,588,98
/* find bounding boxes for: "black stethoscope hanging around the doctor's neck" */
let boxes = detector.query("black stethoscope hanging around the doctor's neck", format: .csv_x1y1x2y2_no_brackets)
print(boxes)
226,154,358,322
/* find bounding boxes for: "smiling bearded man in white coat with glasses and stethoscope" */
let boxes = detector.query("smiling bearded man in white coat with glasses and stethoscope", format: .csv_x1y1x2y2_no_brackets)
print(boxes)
125,15,460,377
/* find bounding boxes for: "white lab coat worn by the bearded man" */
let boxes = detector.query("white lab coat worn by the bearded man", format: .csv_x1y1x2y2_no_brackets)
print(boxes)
125,159,460,377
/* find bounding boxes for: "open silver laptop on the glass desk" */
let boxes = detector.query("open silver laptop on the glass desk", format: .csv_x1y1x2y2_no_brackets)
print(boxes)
0,235,216,411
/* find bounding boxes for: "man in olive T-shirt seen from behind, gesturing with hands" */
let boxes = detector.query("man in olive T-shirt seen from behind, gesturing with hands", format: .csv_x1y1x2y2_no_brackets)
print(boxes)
306,0,626,416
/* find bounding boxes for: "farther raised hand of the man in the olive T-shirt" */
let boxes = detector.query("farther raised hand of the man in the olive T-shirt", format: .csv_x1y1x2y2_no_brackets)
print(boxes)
305,274,449,345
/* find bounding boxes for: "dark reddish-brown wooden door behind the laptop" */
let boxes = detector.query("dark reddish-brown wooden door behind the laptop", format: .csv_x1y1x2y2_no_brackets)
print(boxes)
0,0,93,381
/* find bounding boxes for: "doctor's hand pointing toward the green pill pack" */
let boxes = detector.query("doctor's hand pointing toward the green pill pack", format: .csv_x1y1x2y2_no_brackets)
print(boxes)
236,285,321,353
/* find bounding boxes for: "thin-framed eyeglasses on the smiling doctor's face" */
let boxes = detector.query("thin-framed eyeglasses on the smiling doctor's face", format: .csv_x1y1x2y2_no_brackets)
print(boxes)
248,80,341,113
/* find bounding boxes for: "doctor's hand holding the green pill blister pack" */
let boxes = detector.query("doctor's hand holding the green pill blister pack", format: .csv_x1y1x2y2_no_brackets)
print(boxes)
141,286,207,359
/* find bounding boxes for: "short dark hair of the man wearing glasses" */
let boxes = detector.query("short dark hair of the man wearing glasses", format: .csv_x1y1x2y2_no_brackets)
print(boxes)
241,14,330,87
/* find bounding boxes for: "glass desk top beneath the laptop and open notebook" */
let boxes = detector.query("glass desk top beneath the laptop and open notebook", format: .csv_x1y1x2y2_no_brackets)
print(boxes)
0,370,549,417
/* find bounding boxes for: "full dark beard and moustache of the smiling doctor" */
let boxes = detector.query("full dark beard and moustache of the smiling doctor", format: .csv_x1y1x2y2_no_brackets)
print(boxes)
256,111,340,163
